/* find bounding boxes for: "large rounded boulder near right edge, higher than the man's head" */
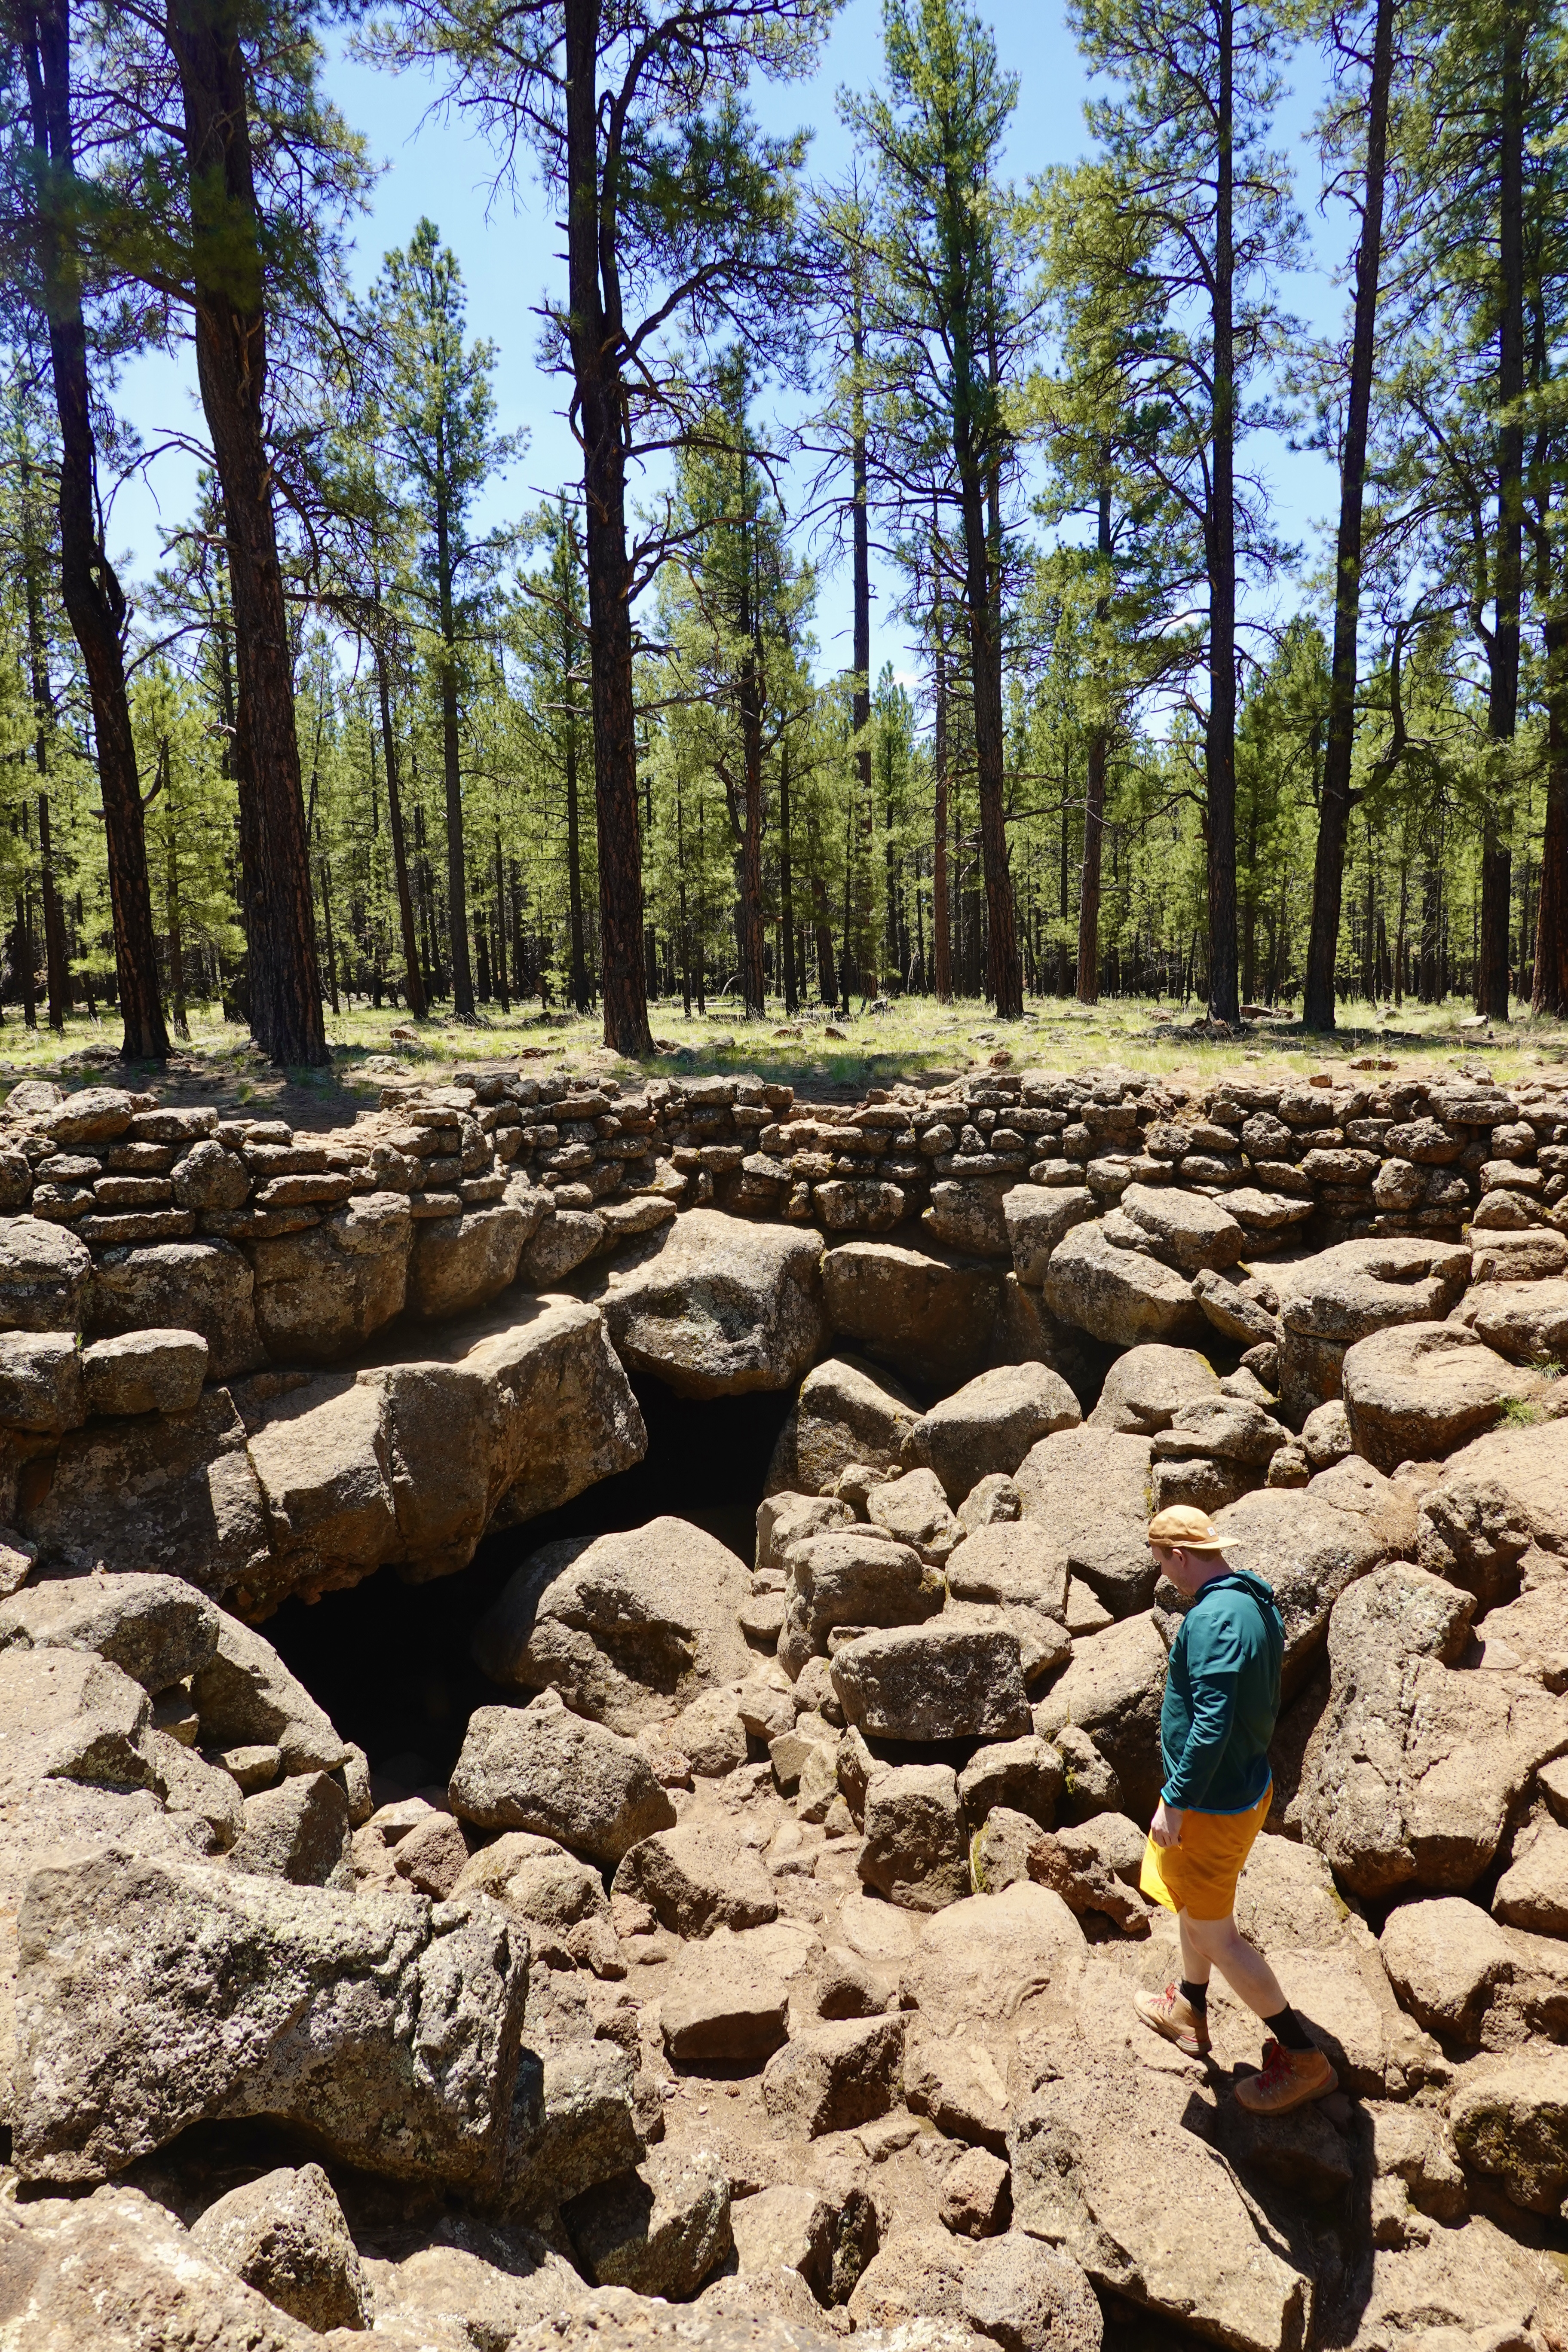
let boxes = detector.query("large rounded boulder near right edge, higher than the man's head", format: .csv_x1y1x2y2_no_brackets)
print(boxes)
1340,1322,1547,1472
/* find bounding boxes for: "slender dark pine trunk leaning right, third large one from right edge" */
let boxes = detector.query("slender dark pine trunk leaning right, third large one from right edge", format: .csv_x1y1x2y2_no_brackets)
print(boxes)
1302,0,1394,1030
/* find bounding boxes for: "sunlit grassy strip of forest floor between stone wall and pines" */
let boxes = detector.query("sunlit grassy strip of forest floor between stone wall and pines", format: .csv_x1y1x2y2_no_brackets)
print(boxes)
0,997,1568,1127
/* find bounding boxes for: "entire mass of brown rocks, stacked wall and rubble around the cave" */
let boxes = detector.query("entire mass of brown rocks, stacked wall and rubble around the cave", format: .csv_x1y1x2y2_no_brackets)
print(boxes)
0,1072,1568,2352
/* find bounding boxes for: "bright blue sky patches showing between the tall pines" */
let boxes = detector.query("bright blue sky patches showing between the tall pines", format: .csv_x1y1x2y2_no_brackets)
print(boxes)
110,0,1347,675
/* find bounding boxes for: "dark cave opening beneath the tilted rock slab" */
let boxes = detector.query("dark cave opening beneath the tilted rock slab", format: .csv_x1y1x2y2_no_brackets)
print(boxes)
263,1381,795,1788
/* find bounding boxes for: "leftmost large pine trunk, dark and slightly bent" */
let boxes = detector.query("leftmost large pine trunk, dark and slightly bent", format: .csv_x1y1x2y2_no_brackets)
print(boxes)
19,0,169,1061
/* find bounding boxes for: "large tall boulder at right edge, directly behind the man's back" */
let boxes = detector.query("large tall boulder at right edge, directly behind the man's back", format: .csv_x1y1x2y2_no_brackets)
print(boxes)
1298,1562,1568,1896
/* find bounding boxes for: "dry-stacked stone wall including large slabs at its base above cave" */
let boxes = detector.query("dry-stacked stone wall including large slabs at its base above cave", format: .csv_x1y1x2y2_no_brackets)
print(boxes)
0,1070,1568,1616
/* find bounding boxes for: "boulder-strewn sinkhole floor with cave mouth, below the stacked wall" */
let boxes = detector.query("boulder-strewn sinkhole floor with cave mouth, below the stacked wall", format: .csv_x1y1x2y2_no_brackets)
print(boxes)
15,1077,1568,2352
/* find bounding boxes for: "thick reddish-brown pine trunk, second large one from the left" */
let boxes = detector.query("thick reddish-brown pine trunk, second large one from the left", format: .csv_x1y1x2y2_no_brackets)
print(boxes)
167,0,327,1063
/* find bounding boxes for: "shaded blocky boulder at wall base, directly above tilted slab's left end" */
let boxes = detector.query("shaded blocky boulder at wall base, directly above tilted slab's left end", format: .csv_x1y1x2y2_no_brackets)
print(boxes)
249,1192,414,1364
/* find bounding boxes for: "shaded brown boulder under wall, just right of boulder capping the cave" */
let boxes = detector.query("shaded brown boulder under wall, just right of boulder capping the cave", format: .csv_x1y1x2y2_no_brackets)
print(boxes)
823,1242,1001,1387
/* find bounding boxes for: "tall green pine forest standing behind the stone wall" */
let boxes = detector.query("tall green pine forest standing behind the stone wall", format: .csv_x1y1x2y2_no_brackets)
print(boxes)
0,0,1568,1066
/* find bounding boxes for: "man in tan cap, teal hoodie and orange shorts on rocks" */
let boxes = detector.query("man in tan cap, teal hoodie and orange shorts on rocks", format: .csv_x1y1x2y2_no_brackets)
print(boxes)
1136,1503,1340,2114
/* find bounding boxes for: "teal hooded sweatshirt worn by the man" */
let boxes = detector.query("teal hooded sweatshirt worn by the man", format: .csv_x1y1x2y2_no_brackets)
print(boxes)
1159,1569,1286,1813
